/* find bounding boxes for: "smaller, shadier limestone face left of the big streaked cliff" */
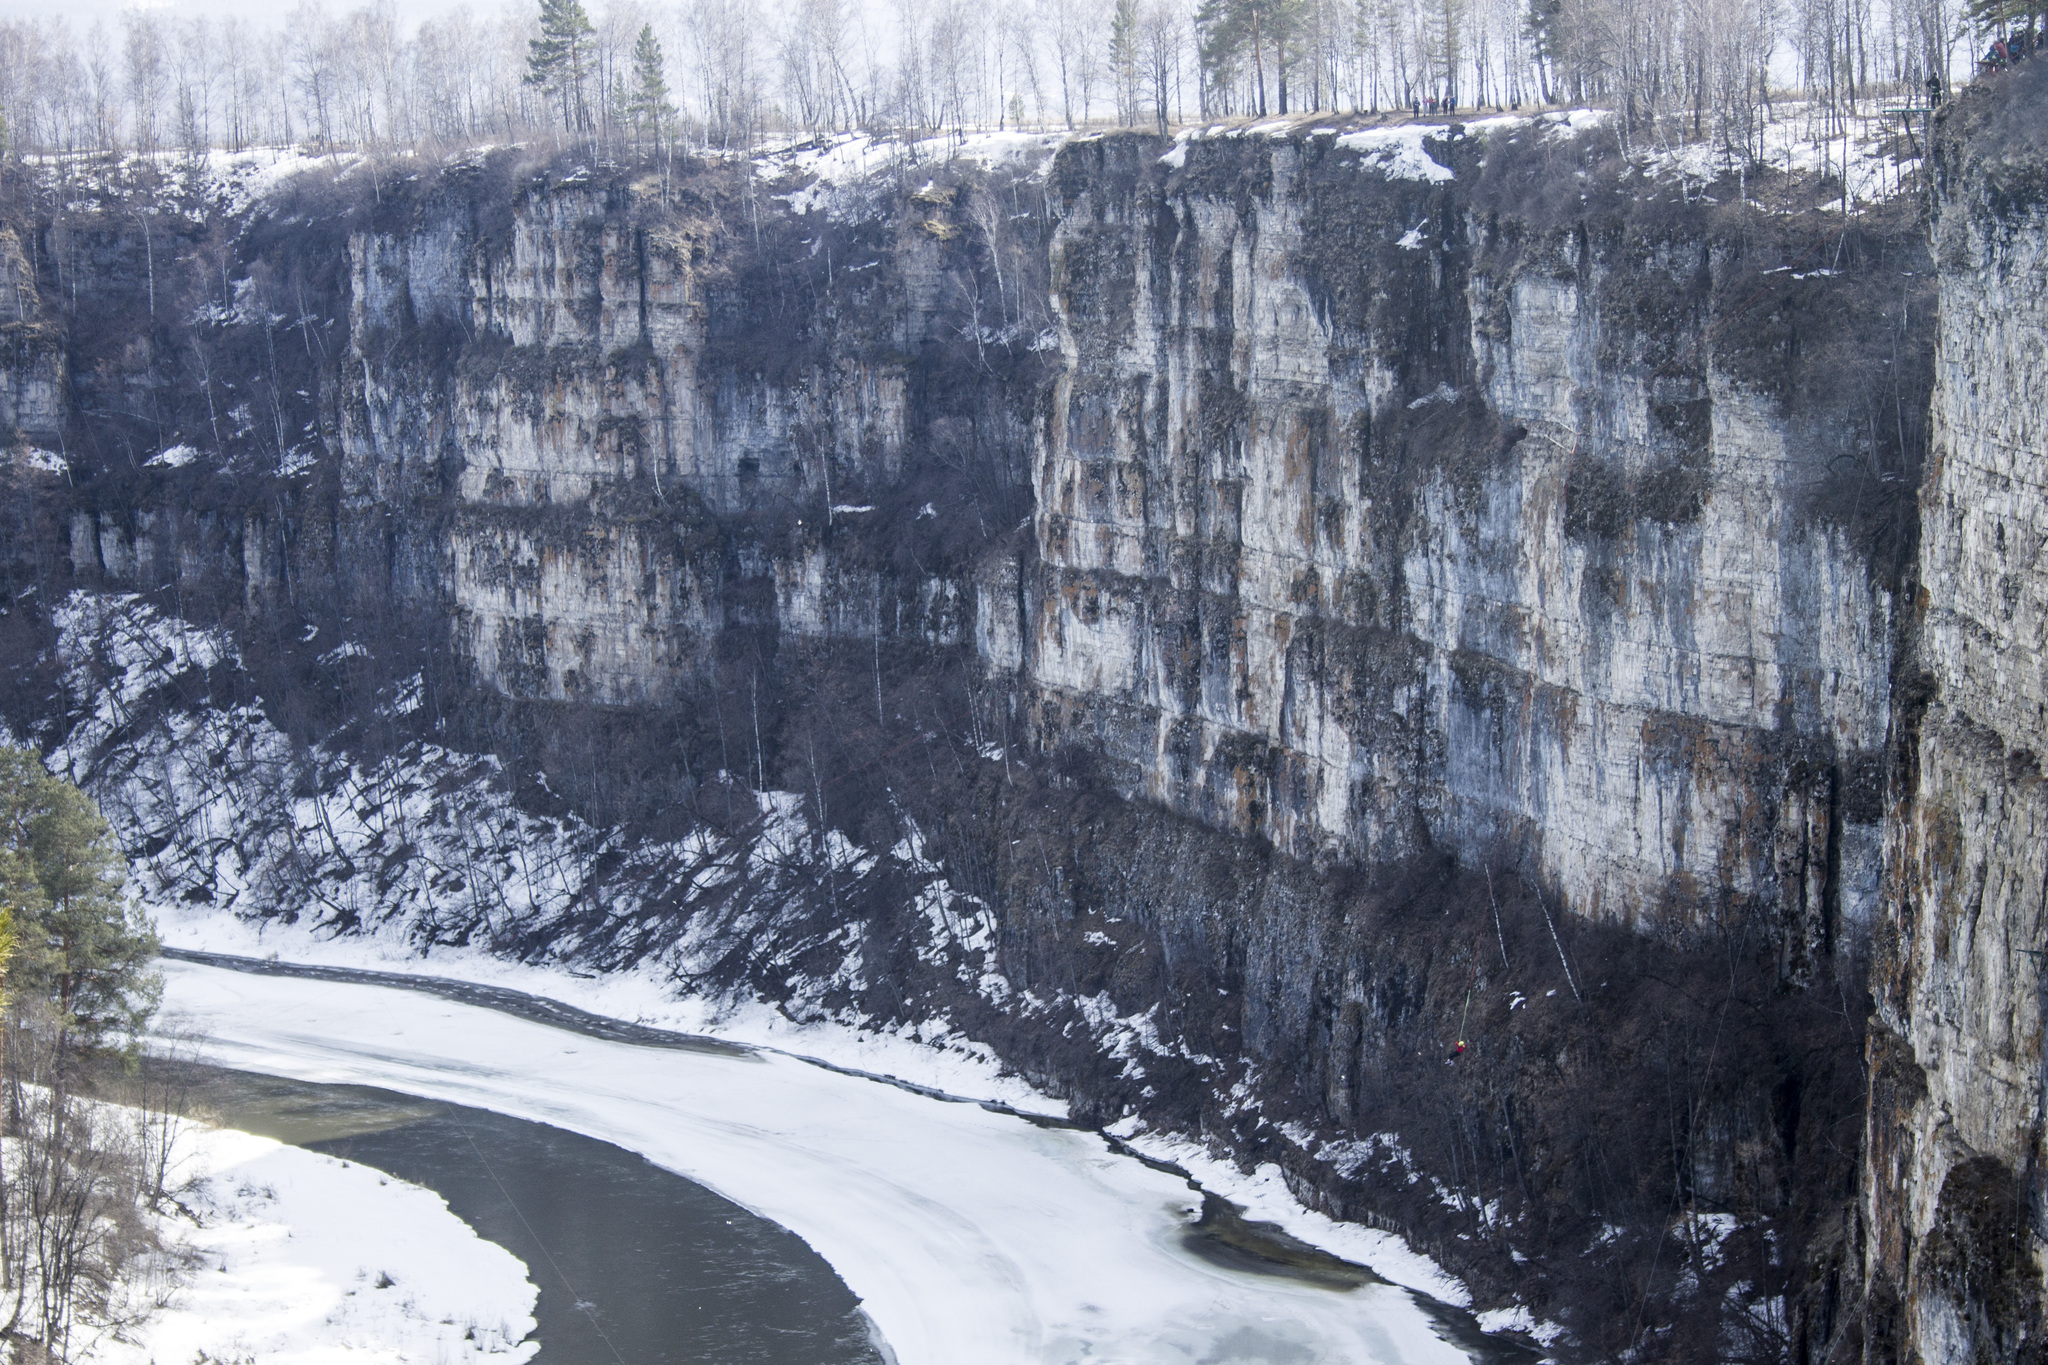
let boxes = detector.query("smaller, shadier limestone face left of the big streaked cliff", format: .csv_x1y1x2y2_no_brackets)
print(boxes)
299,162,1028,706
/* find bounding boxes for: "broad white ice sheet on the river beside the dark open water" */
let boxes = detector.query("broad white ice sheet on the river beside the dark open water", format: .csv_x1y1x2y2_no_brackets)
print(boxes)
164,962,1468,1365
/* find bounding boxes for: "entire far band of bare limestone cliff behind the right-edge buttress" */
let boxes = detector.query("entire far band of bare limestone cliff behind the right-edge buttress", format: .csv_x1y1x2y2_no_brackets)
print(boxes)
56,133,1911,957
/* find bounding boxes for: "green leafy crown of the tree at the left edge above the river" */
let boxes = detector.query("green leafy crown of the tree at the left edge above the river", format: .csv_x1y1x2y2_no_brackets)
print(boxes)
0,749,160,1048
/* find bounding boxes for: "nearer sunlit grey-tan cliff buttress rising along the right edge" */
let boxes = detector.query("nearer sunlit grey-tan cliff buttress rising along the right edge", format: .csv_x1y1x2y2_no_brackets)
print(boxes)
1866,74,2048,1361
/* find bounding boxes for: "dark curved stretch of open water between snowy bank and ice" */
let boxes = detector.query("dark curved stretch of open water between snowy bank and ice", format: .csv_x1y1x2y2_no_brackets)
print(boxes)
195,1068,889,1365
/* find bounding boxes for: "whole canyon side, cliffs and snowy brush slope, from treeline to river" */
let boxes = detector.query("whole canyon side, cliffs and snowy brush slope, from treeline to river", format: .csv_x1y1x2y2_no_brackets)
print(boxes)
0,72,2048,1361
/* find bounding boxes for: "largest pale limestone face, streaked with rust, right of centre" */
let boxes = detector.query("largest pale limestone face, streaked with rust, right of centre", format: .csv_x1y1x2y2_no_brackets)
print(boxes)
1024,125,1892,952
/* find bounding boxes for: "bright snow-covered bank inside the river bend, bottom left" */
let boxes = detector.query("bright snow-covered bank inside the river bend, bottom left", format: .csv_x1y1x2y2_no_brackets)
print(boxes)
110,1130,541,1365
